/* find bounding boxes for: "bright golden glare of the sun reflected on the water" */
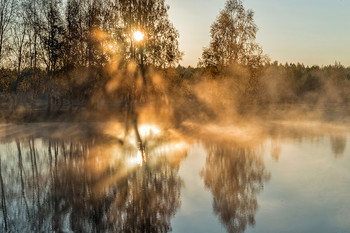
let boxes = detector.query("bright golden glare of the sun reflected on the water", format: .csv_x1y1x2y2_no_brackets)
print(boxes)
104,122,188,167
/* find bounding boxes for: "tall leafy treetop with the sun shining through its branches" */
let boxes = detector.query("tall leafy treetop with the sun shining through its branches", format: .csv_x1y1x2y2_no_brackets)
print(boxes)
113,0,182,68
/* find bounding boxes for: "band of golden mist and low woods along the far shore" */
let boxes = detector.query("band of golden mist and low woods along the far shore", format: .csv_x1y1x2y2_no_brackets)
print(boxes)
0,61,350,124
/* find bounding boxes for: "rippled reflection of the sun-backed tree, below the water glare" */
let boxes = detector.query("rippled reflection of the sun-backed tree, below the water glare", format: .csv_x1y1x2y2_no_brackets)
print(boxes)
104,159,181,232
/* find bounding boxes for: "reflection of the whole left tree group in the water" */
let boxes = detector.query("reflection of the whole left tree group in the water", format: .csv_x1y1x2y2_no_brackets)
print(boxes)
0,124,186,232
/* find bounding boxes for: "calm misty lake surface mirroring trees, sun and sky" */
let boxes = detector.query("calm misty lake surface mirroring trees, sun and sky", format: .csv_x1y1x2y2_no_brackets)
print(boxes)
0,121,350,233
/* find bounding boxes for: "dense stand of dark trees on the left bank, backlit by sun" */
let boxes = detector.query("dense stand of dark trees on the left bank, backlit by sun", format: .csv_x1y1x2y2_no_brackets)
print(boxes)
0,0,182,117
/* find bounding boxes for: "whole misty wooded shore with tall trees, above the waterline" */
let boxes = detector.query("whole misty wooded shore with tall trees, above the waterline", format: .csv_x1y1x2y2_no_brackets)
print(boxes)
0,0,350,122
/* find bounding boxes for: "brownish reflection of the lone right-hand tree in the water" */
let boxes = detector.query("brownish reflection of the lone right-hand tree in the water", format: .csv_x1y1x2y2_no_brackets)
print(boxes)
202,145,270,232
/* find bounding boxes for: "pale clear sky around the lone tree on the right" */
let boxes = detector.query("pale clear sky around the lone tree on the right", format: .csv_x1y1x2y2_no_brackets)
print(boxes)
166,0,350,67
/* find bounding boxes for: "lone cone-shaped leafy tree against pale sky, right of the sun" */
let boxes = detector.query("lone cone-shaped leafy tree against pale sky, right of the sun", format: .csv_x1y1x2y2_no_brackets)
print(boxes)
199,0,265,67
